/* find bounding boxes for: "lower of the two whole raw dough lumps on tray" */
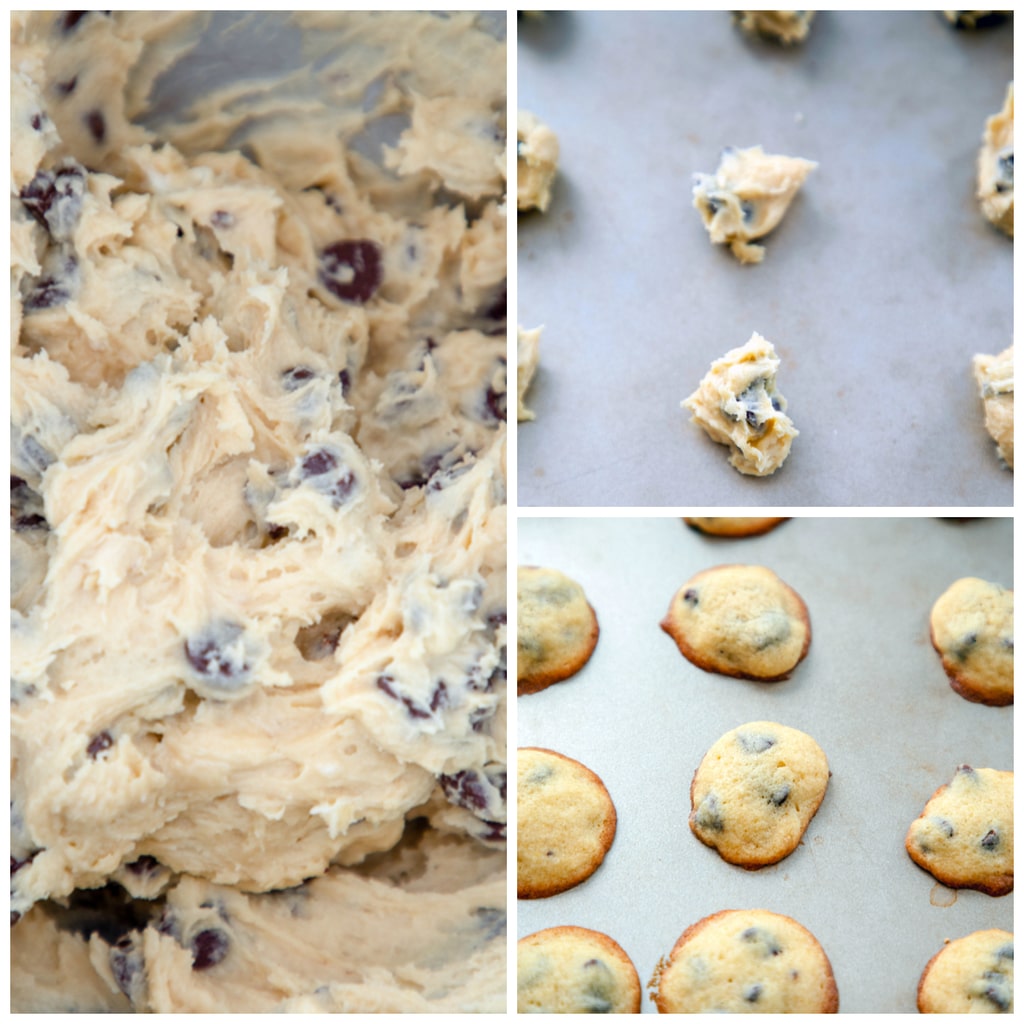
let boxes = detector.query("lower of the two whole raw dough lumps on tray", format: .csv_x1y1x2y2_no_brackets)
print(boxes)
682,332,800,476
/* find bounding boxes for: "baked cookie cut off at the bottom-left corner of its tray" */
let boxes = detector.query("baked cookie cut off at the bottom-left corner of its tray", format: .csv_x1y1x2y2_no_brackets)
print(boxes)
516,925,640,1014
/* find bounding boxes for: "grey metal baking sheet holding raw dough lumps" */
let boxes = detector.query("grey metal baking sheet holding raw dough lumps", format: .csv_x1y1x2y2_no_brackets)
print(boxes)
517,11,1013,507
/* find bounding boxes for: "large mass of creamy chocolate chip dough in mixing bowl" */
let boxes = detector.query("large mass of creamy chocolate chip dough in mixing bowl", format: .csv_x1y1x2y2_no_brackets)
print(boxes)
10,11,506,1012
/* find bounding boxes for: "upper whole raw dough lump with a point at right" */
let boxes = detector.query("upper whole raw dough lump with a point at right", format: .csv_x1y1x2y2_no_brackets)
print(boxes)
693,145,818,263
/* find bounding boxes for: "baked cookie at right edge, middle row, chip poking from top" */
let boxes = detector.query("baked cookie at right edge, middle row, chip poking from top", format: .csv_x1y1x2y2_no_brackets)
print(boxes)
906,765,1014,896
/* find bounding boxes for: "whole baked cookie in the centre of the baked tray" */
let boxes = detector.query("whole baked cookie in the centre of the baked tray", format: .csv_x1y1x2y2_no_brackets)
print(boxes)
690,722,828,868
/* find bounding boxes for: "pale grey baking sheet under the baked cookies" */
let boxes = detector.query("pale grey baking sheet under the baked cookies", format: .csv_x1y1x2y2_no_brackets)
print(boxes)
516,518,1013,1013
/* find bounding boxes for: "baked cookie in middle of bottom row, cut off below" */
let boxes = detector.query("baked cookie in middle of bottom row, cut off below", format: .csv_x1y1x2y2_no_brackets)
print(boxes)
650,910,839,1014
